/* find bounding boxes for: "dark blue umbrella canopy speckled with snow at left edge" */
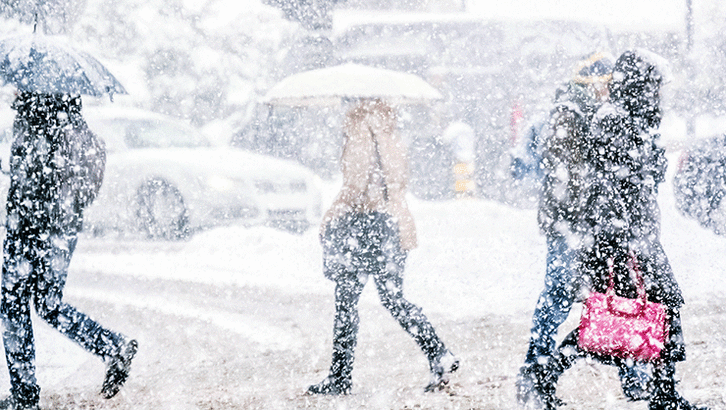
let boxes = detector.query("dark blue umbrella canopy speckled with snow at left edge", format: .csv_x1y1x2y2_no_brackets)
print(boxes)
0,34,126,97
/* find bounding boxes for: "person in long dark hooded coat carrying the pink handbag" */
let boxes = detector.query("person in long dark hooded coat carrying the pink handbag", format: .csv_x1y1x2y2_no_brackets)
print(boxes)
545,50,712,410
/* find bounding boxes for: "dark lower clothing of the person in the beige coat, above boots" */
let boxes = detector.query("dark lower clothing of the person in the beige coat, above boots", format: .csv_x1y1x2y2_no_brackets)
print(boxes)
323,212,446,380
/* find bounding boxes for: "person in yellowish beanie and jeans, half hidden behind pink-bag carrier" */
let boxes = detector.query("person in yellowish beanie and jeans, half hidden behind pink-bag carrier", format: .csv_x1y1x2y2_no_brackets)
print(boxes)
516,53,613,407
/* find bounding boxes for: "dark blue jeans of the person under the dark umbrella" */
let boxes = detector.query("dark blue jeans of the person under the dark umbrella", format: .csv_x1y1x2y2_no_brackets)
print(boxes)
0,231,123,405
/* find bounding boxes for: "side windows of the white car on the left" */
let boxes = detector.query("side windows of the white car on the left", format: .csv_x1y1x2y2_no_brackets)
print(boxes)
94,119,209,151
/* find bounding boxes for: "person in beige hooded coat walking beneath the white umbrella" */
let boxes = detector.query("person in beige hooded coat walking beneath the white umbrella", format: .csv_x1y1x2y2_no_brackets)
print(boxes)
308,99,459,395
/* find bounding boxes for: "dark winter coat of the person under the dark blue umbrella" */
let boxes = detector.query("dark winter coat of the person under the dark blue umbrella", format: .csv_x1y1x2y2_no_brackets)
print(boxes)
6,93,106,236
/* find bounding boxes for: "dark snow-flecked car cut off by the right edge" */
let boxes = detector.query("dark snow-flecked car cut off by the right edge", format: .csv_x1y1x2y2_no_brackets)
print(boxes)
673,134,726,235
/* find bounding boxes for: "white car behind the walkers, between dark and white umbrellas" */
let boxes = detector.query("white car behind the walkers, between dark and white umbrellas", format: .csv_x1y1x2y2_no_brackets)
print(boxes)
4,106,321,239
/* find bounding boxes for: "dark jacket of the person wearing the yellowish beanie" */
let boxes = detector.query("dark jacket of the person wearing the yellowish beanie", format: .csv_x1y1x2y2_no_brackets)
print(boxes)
538,82,600,235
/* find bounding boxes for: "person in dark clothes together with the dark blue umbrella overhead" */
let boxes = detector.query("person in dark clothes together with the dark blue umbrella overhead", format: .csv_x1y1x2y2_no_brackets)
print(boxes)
0,33,138,410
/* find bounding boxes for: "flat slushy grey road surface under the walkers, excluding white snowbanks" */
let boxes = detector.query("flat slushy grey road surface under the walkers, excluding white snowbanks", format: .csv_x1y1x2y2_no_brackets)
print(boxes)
14,247,726,409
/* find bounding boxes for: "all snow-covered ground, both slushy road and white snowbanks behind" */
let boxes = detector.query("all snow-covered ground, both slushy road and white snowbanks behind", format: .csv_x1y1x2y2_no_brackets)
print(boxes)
0,155,726,410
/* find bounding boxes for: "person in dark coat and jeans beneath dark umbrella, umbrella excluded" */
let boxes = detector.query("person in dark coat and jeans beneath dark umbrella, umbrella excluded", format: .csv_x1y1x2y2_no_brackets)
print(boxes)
0,92,138,409
